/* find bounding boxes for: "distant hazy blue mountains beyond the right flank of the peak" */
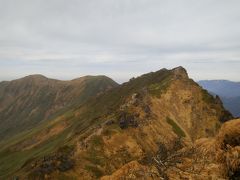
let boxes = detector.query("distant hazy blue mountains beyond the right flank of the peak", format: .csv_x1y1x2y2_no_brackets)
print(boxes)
198,80,240,117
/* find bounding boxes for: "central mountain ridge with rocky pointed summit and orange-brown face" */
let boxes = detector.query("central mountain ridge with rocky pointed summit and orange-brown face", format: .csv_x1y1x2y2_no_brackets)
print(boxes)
0,67,232,179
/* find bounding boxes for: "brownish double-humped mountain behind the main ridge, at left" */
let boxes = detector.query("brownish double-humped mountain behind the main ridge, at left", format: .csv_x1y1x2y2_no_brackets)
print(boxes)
0,75,117,141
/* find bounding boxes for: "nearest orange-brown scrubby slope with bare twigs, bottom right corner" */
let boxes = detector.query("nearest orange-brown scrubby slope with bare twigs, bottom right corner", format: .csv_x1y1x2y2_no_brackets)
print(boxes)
101,119,240,180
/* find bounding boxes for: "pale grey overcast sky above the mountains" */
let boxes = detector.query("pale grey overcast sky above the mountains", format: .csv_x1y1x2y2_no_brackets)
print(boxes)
0,0,240,83
